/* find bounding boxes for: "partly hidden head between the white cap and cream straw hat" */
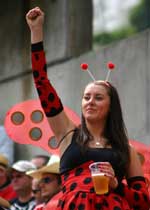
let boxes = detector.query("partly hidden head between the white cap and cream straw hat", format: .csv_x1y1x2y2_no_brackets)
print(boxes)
31,155,50,169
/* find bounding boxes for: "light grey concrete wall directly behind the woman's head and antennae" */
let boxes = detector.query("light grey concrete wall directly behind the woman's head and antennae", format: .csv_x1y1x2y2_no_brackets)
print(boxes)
0,30,150,157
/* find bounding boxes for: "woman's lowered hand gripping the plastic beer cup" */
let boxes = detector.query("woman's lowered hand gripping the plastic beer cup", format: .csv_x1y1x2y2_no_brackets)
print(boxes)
100,162,118,189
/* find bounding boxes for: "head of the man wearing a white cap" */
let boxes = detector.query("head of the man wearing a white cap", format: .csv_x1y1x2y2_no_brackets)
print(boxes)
11,160,36,197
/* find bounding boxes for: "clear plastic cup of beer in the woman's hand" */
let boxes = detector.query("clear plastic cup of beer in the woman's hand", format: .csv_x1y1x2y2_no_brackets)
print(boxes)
89,162,109,195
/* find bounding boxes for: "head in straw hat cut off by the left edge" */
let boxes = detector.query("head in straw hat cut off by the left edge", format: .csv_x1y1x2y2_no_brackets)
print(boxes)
0,154,9,187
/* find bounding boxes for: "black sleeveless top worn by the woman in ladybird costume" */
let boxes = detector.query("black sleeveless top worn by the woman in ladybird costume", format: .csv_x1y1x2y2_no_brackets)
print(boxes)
60,130,124,181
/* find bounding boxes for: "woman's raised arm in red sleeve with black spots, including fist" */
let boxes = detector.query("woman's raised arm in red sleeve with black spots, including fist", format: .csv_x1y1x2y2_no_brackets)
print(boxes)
26,7,75,144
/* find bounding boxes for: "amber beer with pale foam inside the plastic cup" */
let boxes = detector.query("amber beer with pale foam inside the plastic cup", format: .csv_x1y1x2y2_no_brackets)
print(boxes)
92,173,109,195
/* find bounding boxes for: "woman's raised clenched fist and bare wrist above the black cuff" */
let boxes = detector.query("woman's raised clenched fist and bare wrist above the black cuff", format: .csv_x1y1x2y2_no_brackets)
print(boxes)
26,7,44,43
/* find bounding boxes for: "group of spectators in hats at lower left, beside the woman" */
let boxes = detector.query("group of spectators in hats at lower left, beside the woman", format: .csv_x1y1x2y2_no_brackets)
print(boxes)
0,154,61,210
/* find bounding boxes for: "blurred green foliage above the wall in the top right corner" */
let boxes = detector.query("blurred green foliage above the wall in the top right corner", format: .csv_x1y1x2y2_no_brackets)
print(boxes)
93,0,150,45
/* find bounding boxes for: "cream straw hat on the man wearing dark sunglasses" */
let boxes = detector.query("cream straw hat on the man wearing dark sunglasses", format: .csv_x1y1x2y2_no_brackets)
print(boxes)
26,155,60,179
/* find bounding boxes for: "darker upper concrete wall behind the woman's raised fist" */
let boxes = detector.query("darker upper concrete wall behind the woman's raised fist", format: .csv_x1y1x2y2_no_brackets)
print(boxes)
0,0,92,83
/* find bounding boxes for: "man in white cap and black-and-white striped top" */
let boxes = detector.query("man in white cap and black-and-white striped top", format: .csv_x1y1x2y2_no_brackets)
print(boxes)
10,160,36,210
